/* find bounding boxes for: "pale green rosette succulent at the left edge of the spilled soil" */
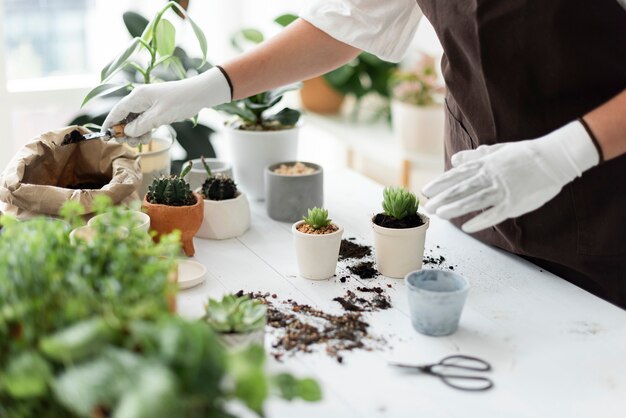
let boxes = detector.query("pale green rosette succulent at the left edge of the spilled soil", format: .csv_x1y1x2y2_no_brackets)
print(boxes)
205,295,267,334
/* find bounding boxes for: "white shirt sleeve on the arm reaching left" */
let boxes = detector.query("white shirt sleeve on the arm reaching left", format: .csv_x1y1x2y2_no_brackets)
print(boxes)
300,0,422,62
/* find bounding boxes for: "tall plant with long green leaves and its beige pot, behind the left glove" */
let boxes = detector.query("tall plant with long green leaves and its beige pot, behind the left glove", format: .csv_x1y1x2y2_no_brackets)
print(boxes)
82,1,207,196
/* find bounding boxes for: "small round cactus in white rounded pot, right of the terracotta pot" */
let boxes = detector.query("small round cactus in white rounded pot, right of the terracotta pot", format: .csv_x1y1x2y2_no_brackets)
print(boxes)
196,158,250,239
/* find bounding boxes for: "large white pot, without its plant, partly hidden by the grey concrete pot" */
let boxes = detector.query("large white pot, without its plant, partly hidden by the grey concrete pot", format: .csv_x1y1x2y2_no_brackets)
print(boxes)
226,127,299,200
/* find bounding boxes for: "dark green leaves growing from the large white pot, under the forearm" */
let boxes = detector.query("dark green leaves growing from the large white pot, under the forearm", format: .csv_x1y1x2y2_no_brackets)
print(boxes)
215,84,300,131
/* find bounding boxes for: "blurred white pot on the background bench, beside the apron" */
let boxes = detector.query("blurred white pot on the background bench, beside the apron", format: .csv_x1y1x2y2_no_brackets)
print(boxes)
391,100,445,155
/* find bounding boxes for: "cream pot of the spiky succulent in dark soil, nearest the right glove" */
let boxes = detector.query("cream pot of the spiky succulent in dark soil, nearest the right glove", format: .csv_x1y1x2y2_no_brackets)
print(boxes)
372,213,429,279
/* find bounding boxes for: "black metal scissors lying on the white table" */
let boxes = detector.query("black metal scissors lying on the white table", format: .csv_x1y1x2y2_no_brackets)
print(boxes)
390,354,493,392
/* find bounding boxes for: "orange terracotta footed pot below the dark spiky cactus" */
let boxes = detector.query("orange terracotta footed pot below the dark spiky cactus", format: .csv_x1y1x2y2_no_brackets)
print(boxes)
143,192,204,257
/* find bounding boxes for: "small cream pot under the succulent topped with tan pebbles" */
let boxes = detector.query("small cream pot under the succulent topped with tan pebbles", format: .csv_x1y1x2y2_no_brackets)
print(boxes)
291,221,343,280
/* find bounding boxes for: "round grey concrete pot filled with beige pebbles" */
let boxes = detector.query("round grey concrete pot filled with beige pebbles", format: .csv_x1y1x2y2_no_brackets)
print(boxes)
265,161,324,222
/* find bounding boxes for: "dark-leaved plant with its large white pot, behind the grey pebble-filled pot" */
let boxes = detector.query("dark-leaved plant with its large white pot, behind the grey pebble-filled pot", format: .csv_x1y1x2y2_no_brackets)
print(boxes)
215,85,300,200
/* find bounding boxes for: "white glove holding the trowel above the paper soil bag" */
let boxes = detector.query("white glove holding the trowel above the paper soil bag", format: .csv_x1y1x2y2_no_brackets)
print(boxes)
102,67,231,146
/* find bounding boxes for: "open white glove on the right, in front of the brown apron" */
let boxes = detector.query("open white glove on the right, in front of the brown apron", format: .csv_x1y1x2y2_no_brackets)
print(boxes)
422,121,600,233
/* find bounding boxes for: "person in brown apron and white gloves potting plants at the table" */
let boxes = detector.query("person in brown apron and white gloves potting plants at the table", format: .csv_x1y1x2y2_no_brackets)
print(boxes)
104,0,626,308
